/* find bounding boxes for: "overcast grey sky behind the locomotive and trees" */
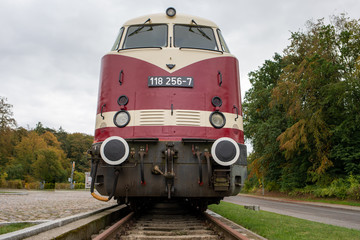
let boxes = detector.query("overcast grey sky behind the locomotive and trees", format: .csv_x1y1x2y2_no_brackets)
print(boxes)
0,0,360,134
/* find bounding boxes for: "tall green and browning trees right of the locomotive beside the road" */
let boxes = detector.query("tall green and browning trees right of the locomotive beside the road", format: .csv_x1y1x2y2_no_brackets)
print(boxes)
244,14,360,190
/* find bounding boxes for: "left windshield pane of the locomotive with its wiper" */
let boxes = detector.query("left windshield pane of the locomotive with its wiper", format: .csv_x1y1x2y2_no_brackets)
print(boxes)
123,24,167,49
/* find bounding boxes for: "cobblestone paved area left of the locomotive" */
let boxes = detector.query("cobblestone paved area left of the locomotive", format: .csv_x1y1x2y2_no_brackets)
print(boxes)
0,189,116,225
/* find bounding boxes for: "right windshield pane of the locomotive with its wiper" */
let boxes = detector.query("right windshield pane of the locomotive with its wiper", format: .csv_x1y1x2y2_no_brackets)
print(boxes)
174,25,218,50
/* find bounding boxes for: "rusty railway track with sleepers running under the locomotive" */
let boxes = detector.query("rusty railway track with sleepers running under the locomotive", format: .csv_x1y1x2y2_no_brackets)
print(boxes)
93,202,264,240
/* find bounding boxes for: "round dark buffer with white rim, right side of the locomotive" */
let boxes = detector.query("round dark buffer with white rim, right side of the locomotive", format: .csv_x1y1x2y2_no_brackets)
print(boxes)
211,137,240,166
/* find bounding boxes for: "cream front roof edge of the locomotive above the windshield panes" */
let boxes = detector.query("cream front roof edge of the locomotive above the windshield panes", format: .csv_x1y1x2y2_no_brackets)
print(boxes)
124,13,218,28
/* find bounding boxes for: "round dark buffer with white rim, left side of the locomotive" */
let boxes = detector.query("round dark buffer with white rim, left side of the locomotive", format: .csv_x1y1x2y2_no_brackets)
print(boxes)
100,136,129,165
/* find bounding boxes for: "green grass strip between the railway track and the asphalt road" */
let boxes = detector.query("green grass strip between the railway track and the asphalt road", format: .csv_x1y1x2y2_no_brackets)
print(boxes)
209,202,360,240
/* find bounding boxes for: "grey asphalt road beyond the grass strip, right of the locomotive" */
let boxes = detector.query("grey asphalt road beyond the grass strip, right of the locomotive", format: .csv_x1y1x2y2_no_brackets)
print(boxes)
224,195,360,230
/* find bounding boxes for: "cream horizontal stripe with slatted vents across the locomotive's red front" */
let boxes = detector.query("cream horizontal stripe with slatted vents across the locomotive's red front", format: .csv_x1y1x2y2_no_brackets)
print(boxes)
95,109,243,131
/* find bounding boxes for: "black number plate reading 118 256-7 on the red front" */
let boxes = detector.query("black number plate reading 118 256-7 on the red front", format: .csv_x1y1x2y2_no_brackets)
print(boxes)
148,76,194,87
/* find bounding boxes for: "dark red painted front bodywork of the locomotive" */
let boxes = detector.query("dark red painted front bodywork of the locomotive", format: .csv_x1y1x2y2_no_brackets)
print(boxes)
95,54,244,143
